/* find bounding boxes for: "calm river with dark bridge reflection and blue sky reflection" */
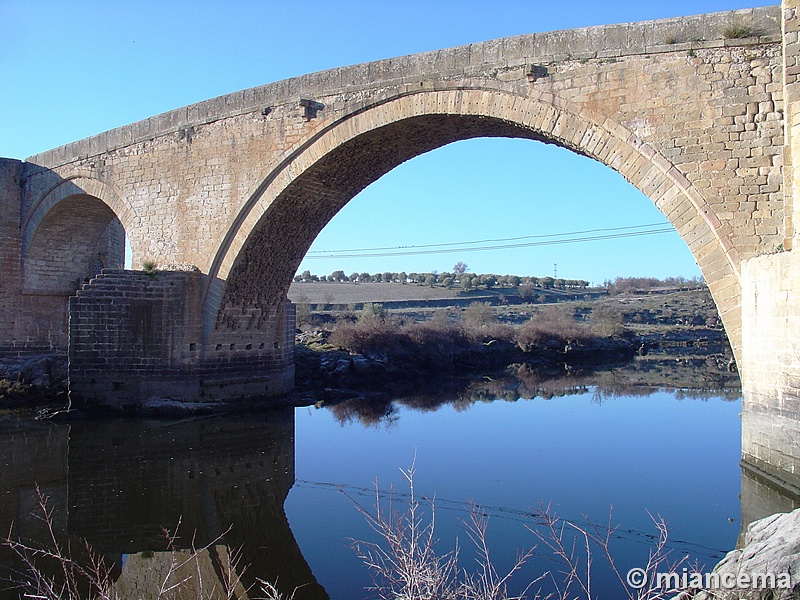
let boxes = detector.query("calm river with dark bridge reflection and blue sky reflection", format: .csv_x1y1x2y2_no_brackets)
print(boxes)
0,387,768,600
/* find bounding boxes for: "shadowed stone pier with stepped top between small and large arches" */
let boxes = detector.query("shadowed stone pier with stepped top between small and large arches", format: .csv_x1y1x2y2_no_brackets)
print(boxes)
69,270,294,410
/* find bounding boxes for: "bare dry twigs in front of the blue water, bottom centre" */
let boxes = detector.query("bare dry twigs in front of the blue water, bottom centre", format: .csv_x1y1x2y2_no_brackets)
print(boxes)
351,465,687,600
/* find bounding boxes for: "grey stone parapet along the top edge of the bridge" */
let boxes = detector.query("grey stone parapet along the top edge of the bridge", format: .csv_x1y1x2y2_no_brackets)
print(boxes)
26,6,781,172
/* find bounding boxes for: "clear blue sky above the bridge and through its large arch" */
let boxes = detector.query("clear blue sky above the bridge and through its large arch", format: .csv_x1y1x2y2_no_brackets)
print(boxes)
0,0,771,282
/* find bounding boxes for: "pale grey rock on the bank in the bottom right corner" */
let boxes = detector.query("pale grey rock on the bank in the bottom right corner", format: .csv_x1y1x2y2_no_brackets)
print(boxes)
676,509,800,600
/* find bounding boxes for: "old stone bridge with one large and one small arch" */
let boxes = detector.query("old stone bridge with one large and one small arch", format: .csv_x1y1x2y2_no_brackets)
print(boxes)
0,0,800,486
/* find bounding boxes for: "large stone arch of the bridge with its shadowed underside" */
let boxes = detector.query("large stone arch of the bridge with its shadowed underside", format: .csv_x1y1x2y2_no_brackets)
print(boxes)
203,88,741,356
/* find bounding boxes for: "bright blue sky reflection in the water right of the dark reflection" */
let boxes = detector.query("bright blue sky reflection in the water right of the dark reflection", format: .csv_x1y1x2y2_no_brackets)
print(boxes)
285,392,741,599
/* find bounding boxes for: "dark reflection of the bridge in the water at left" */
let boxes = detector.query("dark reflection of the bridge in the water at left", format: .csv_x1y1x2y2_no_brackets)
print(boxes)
0,409,328,600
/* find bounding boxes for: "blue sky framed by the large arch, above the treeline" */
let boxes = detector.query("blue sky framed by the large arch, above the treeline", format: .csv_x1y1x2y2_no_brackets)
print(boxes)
295,138,701,285
